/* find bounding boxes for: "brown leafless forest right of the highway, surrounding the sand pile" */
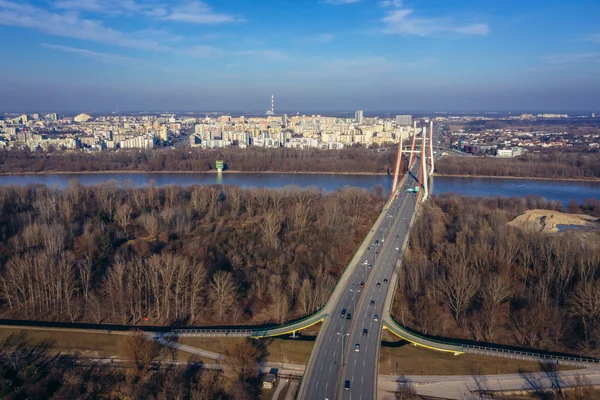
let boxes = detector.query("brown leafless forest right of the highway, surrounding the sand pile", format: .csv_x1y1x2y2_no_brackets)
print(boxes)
394,195,600,355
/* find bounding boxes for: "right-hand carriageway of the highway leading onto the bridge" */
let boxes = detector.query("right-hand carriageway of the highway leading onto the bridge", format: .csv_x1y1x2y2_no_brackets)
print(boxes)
341,167,417,400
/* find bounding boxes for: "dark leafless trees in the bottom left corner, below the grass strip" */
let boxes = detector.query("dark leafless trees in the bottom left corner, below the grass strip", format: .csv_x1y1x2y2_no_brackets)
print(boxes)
0,334,263,400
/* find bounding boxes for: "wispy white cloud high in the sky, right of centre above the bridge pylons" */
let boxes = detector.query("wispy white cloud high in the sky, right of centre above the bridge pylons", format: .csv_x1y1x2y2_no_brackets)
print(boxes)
381,9,490,37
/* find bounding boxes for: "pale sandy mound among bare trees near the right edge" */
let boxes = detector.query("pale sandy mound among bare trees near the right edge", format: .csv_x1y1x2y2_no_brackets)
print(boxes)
508,210,600,233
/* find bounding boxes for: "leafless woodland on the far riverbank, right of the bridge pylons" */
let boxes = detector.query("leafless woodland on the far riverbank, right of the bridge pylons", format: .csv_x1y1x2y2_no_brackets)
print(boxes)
435,151,600,179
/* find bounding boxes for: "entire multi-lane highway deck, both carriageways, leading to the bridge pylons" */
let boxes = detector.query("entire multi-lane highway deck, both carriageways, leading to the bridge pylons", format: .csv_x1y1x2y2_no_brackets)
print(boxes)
299,160,417,400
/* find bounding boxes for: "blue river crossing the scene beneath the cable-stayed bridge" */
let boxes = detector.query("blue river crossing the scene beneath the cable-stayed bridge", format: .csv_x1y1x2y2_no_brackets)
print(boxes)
0,173,600,203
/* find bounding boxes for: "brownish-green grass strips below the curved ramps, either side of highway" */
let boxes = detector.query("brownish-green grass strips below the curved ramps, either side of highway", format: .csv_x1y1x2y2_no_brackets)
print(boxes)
0,327,580,375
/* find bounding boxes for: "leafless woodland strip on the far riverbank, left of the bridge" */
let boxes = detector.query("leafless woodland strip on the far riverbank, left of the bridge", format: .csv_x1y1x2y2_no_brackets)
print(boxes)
0,147,396,173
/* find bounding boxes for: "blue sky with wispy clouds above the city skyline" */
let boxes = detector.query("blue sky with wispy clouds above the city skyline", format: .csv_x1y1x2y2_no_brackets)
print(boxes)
0,0,600,112
